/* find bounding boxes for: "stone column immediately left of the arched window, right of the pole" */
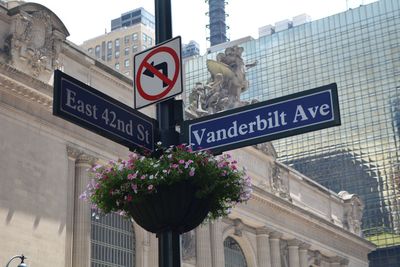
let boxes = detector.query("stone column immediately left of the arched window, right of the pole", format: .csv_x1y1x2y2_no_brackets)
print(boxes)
210,220,225,267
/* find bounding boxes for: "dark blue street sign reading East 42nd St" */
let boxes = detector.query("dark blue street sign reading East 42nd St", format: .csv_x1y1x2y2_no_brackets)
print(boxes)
53,70,157,151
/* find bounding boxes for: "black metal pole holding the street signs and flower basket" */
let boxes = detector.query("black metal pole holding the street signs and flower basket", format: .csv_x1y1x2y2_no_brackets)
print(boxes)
154,0,181,267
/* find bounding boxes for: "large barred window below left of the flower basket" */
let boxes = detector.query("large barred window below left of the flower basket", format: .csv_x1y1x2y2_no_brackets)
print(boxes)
90,213,136,267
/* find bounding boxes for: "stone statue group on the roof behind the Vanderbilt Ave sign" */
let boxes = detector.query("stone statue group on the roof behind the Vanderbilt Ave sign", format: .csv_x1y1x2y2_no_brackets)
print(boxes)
185,46,257,118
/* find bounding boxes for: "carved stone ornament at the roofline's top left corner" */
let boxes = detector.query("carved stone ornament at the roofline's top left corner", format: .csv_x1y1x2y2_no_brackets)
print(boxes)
4,3,68,82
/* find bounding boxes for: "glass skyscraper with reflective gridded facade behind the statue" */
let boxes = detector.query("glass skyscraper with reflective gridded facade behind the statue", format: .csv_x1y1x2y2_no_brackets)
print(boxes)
185,0,400,266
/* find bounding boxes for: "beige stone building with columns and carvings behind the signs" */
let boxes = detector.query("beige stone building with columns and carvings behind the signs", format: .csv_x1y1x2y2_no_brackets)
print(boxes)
0,2,375,267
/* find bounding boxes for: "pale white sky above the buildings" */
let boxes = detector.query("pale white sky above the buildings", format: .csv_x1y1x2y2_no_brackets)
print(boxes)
26,0,376,51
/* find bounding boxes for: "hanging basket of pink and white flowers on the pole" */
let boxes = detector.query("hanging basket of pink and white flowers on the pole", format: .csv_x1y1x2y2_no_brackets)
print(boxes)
82,145,251,233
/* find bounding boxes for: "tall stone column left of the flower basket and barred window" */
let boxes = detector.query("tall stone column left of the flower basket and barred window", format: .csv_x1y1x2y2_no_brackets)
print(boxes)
72,152,96,267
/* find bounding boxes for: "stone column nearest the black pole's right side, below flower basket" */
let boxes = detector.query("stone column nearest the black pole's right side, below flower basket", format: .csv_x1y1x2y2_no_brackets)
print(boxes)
196,223,211,267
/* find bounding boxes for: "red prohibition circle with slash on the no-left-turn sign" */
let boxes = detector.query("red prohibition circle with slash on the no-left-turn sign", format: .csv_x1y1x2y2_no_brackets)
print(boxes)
136,46,179,100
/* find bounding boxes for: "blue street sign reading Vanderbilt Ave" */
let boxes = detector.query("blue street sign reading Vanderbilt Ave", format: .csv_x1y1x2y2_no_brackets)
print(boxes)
183,83,340,153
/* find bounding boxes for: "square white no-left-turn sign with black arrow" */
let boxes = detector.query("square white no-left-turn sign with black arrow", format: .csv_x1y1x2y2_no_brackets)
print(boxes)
134,36,183,108
